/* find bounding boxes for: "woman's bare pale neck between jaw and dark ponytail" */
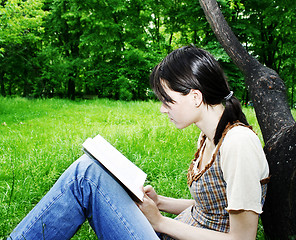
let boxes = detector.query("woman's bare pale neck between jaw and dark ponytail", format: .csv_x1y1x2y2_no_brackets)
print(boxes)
195,104,224,142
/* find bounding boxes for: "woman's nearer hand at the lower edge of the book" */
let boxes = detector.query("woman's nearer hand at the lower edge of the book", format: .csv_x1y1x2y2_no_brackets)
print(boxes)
137,191,163,232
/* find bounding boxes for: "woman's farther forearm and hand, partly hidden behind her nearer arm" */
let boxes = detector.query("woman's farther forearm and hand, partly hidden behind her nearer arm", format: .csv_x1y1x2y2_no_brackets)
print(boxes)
144,185,194,215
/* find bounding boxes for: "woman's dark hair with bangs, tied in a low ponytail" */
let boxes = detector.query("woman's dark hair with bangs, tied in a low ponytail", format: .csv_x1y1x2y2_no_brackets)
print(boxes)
150,45,249,145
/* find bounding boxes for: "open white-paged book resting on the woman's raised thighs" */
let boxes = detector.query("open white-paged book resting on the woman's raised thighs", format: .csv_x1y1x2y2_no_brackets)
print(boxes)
82,135,147,201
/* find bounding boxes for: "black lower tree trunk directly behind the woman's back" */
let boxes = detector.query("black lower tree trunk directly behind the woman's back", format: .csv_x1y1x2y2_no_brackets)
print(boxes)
262,124,296,240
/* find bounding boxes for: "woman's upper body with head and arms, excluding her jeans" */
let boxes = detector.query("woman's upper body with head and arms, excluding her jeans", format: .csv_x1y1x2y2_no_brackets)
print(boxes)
139,46,269,240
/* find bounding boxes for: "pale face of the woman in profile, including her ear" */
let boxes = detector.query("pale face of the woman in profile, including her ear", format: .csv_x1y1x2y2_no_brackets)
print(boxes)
160,86,202,129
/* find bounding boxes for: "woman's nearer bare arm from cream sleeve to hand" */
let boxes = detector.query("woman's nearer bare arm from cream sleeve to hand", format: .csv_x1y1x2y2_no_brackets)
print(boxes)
139,195,258,240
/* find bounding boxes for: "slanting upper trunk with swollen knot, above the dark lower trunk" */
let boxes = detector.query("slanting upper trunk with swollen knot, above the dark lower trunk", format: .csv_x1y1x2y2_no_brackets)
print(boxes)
199,0,295,142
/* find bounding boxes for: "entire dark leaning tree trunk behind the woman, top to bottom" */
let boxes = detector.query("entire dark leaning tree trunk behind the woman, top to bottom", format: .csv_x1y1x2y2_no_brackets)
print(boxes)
199,0,296,239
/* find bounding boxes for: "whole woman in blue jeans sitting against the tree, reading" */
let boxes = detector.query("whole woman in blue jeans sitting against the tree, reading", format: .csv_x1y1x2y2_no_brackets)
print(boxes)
8,46,269,240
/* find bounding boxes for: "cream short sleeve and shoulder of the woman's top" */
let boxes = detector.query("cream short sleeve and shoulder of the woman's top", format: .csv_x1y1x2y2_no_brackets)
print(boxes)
220,126,269,214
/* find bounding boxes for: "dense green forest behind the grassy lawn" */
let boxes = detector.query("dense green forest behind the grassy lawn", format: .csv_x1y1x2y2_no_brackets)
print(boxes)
0,0,296,107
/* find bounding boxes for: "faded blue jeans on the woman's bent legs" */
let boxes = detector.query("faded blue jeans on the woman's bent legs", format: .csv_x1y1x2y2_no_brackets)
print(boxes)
8,155,159,240
